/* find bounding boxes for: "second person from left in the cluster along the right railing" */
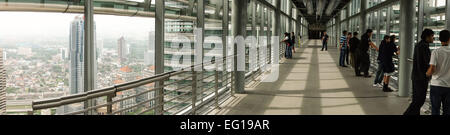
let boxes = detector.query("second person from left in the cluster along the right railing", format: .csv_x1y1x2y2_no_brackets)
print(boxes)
349,32,361,76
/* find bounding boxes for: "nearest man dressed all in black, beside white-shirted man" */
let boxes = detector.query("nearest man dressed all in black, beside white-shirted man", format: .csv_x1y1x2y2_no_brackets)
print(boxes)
403,29,434,115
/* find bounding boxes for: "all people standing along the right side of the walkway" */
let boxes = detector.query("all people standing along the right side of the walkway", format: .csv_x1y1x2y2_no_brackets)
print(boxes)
322,29,450,115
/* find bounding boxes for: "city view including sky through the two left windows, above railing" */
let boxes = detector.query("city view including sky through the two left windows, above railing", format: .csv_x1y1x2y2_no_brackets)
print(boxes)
0,12,158,112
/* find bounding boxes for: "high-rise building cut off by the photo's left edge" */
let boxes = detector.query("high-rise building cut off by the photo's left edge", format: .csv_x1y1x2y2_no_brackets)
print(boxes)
0,48,6,115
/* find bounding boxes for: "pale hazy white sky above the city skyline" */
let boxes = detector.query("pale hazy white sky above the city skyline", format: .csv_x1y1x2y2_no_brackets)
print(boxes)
0,12,155,40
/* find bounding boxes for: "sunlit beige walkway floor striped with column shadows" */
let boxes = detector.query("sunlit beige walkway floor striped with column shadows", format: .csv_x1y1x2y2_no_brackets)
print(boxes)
211,40,409,115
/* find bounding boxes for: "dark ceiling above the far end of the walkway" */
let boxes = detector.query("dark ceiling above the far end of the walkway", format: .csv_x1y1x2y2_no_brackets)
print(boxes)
292,0,350,26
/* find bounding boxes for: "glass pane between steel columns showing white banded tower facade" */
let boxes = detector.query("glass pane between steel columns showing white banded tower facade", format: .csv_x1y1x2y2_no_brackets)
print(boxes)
164,0,196,114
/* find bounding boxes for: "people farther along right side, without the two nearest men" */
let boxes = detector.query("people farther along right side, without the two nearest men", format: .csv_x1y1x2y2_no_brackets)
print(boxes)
322,29,400,92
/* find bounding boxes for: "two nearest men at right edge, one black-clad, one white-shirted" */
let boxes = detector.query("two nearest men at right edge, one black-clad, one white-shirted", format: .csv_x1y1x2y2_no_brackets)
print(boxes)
404,29,450,115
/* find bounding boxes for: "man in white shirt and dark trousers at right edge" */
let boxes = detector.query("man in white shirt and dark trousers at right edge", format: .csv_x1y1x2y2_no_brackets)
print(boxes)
427,30,450,115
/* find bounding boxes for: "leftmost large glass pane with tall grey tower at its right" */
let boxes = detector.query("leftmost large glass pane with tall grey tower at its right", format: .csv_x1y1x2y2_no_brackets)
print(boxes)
0,0,84,115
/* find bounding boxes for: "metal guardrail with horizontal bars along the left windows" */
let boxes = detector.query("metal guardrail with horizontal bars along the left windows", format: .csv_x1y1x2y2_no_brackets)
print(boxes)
28,56,243,115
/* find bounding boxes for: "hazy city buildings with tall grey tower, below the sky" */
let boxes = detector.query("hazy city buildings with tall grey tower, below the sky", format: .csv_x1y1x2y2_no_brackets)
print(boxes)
0,16,154,114
